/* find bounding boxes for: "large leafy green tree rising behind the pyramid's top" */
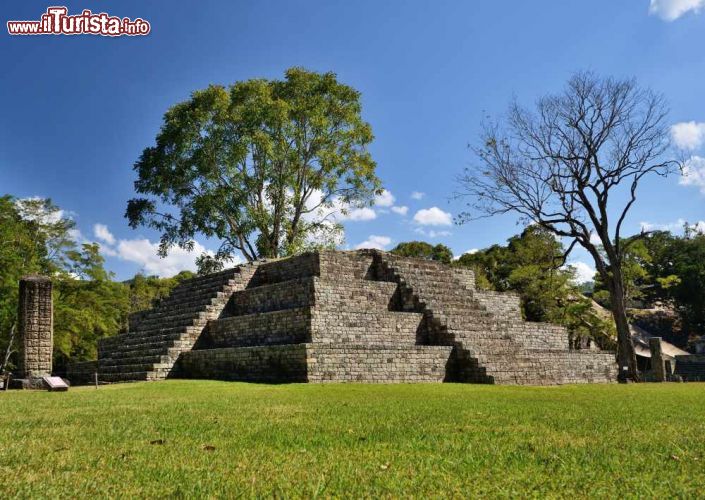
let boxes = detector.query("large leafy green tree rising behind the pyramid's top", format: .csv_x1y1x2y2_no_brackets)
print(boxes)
126,68,380,268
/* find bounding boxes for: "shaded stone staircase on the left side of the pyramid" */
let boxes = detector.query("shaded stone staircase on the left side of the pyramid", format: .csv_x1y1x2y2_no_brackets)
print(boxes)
98,266,254,382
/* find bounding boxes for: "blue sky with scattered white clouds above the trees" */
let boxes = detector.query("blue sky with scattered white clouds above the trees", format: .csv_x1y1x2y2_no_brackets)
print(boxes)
0,0,705,279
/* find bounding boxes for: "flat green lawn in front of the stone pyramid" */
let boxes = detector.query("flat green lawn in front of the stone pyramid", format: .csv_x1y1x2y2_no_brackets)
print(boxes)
0,381,705,498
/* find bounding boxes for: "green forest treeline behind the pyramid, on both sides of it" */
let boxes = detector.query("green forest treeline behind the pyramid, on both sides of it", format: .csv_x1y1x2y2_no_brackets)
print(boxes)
0,195,705,371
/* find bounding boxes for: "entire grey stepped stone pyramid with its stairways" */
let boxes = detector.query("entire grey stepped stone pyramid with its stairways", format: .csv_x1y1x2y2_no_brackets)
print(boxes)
69,250,617,385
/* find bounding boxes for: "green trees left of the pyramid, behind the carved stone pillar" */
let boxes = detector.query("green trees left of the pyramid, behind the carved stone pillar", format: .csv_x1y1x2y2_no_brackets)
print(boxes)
0,196,192,372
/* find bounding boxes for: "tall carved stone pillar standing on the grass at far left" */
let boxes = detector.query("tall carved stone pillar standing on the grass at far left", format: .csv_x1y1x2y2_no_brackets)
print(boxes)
18,276,54,378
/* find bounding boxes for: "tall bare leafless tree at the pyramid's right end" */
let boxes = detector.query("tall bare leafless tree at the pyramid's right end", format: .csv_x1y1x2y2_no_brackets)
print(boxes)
457,73,678,382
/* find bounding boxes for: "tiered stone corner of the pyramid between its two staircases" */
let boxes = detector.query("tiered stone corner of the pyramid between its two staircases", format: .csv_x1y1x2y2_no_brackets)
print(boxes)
180,252,452,383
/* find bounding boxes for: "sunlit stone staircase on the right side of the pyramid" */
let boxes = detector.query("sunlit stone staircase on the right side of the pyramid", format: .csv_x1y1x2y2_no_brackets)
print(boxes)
377,253,616,385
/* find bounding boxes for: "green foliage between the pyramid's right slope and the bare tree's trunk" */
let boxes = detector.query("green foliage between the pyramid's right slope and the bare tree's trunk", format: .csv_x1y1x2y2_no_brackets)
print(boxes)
456,226,614,346
